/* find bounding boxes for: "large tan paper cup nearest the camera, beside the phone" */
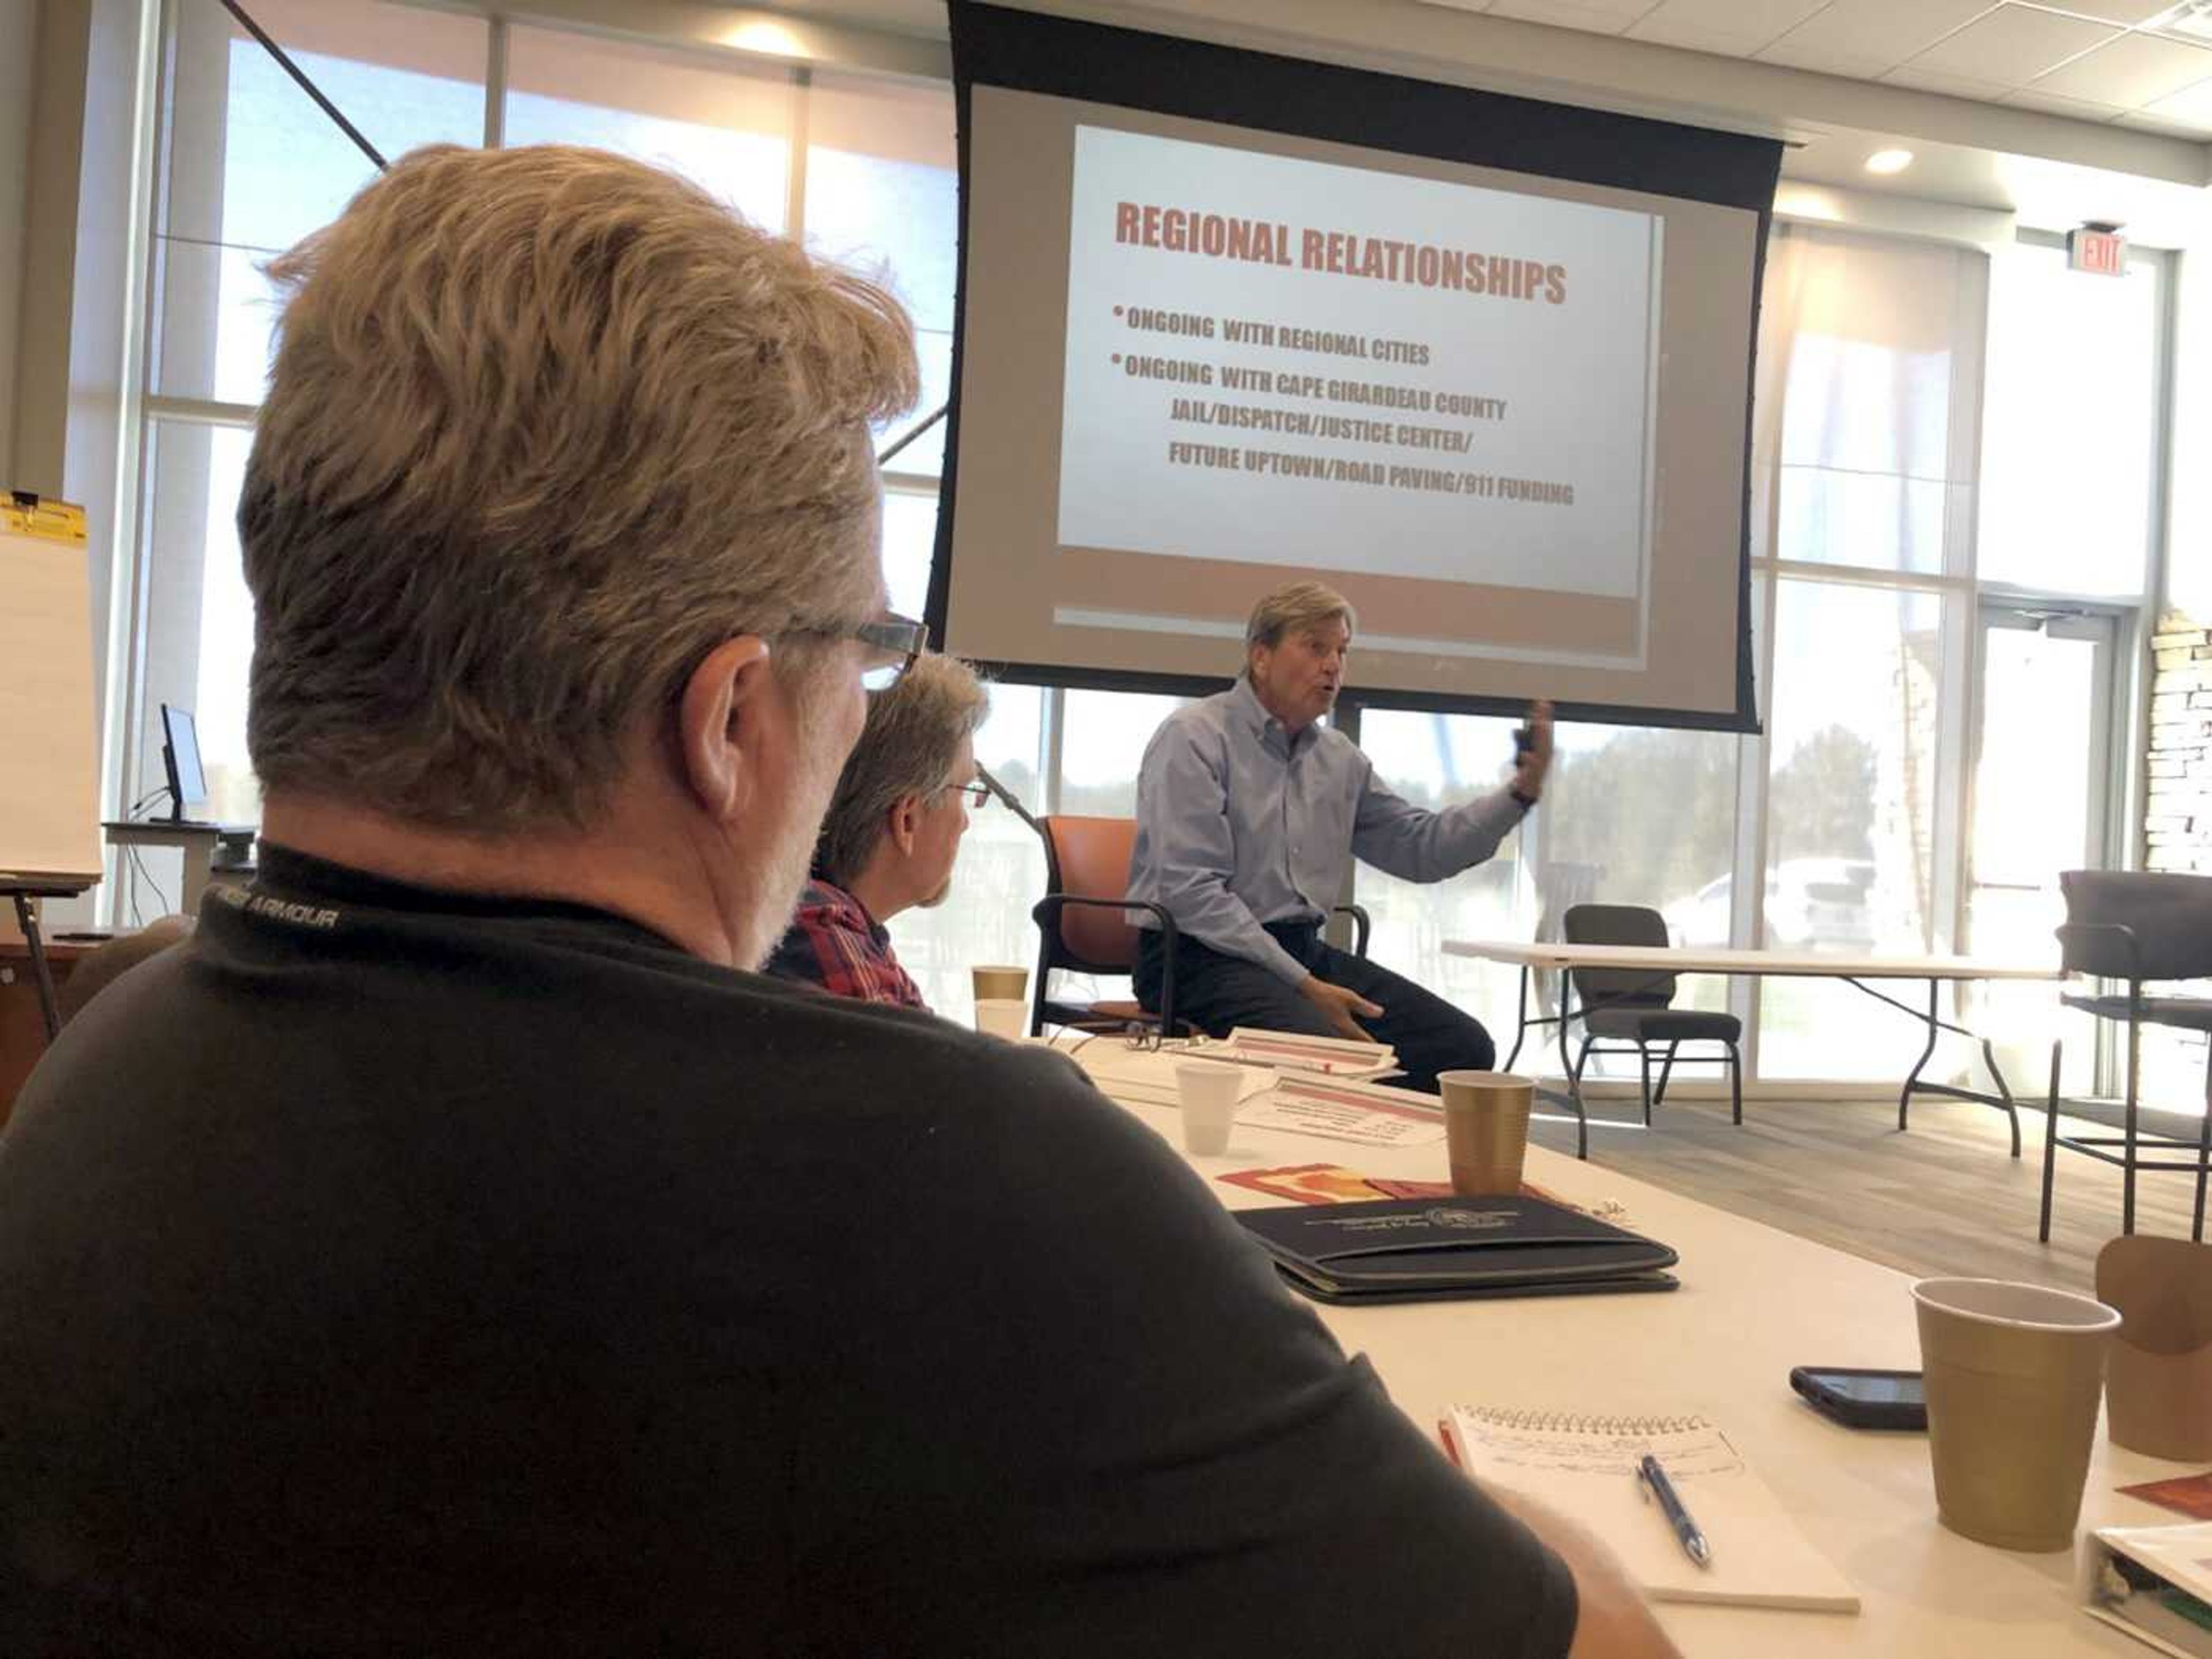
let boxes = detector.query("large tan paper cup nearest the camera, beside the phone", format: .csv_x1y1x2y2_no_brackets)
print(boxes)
1914,1279,2119,1551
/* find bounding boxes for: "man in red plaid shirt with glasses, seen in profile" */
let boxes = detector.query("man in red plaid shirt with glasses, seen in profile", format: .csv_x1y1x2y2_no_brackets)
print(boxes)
767,655,991,1009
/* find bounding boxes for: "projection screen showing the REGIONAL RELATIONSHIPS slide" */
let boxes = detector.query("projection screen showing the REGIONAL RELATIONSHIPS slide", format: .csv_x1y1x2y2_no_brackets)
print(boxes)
931,5,1781,730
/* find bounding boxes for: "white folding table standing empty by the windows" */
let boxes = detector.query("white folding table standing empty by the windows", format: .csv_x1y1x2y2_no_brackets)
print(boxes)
1445,940,2059,1157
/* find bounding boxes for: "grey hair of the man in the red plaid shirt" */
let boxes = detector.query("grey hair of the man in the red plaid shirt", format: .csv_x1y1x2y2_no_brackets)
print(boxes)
814,653,991,887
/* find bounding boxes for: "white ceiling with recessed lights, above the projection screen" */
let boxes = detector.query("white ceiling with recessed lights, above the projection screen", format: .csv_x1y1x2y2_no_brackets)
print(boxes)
632,0,2212,248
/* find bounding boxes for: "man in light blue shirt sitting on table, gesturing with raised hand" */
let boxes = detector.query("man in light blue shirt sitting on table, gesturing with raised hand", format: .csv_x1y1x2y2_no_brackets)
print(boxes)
1128,582,1551,1093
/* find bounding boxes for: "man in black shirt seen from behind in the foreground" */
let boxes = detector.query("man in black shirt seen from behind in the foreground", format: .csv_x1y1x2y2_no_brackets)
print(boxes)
0,148,1659,1659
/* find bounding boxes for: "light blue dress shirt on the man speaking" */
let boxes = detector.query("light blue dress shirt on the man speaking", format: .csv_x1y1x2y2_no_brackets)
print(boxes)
1128,677,1527,984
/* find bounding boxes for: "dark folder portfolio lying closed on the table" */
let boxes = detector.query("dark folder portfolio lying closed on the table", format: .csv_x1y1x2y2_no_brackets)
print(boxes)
1237,1196,1677,1303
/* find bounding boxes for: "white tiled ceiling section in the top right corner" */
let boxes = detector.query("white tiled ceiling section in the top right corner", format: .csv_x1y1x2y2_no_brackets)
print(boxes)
1427,0,2212,137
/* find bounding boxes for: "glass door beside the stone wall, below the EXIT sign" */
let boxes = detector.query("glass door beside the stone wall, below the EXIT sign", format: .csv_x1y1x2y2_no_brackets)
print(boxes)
1967,600,2119,1095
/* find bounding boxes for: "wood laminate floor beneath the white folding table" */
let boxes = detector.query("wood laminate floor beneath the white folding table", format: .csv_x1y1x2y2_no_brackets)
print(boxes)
1533,1097,2196,1290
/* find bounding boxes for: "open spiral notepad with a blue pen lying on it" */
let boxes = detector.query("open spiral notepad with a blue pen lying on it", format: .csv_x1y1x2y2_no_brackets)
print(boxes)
1442,1404,1858,1612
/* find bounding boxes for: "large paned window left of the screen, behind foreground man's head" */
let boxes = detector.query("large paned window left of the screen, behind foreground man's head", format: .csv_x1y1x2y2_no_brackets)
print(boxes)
138,0,956,909
